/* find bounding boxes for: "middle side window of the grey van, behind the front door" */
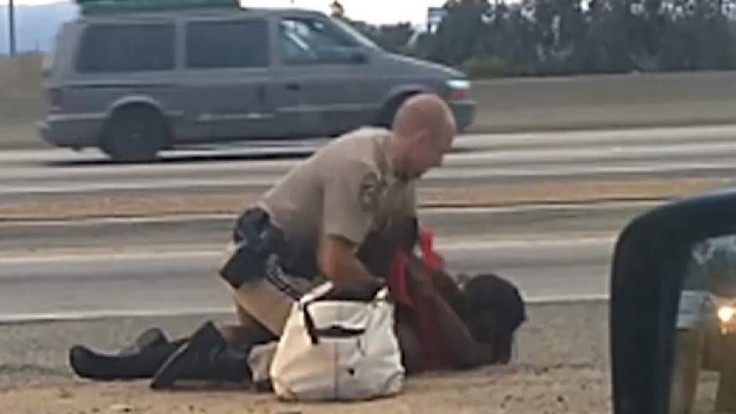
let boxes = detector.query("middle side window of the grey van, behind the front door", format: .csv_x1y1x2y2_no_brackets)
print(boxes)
186,20,269,69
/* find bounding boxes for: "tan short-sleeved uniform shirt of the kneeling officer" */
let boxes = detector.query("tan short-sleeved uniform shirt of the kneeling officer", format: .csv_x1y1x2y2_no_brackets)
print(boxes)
259,128,416,248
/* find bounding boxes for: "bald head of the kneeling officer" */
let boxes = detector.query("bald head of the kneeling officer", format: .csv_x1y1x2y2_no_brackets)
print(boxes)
392,94,457,179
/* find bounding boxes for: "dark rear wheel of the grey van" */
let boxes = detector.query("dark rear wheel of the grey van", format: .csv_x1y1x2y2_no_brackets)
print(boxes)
102,106,169,162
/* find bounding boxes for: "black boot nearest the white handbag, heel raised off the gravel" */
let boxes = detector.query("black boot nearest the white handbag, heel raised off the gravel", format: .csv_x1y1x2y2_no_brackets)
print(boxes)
151,322,251,389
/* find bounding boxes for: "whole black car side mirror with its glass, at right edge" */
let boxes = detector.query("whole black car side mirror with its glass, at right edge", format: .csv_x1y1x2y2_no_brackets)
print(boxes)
610,191,736,414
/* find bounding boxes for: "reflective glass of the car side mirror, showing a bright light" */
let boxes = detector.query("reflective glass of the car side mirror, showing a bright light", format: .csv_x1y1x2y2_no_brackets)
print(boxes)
669,232,736,414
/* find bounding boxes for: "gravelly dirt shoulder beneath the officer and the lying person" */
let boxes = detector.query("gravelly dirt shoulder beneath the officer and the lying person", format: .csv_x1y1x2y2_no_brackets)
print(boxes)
0,302,611,414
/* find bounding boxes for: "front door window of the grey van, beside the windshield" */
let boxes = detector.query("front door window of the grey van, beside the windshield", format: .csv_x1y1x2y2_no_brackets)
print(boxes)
279,17,359,64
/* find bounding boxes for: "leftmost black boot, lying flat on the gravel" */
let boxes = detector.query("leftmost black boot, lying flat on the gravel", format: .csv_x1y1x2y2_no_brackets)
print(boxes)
69,339,187,381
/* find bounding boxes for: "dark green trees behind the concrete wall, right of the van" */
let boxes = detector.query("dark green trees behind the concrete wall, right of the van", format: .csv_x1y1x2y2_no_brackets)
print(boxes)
340,0,736,76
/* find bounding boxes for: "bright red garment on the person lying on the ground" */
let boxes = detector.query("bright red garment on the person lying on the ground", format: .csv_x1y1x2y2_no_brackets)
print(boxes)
389,227,445,370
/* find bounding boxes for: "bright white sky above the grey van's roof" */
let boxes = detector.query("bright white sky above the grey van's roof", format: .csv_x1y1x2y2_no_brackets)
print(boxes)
0,0,445,24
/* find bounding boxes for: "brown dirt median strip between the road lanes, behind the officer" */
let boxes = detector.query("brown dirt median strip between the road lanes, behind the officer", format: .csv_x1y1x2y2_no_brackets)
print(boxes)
0,201,663,249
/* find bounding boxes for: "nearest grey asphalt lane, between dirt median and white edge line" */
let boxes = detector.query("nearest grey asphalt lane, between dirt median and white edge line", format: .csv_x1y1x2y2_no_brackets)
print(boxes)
0,237,613,322
